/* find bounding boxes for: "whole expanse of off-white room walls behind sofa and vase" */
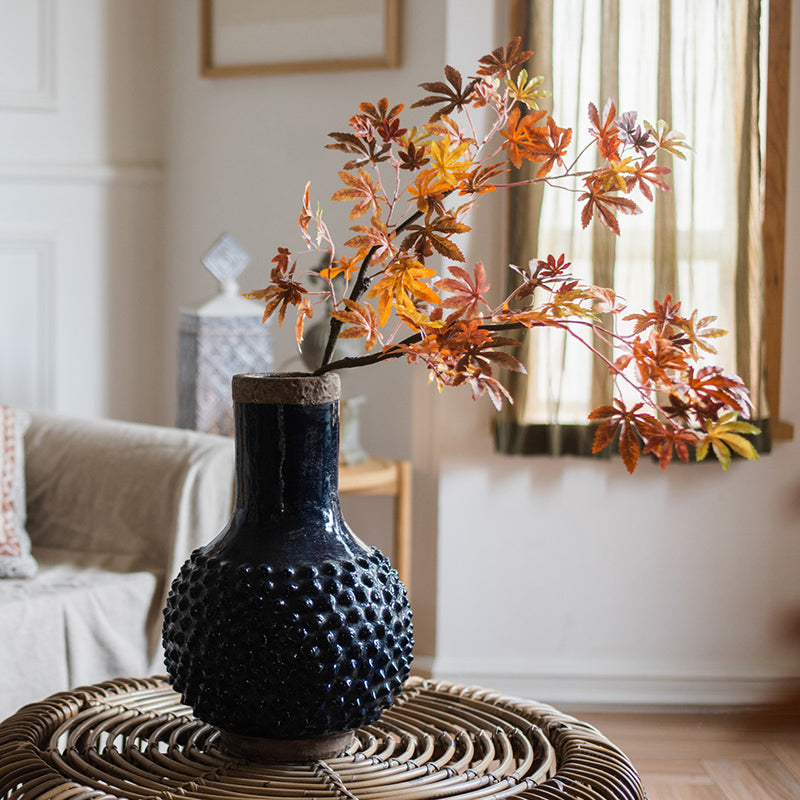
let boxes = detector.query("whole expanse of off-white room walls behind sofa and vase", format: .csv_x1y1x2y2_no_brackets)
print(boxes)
6,0,800,702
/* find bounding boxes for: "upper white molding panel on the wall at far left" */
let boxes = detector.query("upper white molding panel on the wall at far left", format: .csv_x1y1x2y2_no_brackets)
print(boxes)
0,0,57,111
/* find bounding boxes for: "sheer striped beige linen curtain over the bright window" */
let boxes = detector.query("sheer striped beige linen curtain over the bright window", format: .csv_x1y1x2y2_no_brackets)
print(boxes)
496,0,767,455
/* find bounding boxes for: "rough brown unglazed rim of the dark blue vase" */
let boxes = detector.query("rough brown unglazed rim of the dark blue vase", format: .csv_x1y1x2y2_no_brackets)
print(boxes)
232,372,342,406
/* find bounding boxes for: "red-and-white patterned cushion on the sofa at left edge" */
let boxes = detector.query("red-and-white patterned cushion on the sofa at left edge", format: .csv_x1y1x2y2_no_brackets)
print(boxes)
0,405,36,578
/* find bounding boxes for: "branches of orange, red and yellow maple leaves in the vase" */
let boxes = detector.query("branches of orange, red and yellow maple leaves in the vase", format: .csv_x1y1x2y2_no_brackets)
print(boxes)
246,37,758,472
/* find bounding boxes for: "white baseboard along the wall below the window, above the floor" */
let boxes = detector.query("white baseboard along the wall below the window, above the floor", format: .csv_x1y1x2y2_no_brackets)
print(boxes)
418,658,797,708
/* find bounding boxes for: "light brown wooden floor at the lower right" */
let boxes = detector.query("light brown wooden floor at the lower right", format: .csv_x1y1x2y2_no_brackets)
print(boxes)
574,711,800,800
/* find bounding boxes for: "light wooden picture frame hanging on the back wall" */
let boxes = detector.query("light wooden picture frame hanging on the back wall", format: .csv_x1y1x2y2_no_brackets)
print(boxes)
200,0,402,78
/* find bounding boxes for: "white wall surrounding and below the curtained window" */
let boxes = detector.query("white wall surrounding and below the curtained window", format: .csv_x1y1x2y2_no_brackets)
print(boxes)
428,2,800,703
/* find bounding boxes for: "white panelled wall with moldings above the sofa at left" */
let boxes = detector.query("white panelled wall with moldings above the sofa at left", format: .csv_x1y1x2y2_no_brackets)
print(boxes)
0,0,162,421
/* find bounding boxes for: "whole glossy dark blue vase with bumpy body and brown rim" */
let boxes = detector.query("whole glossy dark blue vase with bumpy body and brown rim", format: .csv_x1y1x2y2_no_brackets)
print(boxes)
163,375,413,739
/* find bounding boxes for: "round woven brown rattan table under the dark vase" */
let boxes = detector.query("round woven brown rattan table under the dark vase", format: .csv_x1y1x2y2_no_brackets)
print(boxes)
0,678,645,800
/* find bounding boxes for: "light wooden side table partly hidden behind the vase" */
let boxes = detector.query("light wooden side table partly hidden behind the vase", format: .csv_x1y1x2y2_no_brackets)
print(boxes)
339,458,411,594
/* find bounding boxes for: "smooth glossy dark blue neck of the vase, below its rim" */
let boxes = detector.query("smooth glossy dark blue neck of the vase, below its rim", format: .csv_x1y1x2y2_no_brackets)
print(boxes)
234,401,339,521
